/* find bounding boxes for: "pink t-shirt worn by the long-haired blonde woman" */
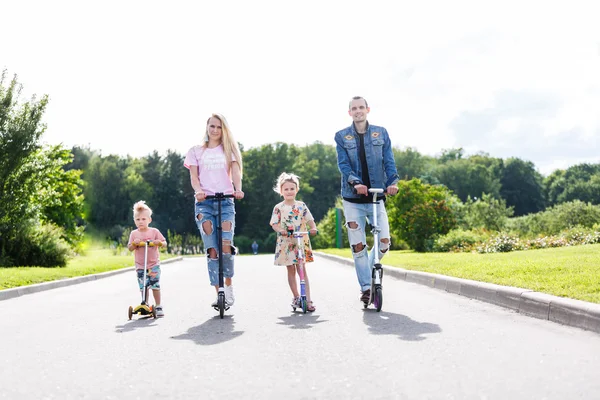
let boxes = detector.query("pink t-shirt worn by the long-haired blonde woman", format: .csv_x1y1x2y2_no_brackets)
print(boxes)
183,145,235,195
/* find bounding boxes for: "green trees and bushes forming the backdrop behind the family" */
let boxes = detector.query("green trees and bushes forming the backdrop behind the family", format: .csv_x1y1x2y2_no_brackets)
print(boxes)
0,72,600,266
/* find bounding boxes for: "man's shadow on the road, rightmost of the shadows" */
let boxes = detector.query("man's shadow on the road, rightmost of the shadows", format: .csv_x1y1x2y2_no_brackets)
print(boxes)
363,309,442,341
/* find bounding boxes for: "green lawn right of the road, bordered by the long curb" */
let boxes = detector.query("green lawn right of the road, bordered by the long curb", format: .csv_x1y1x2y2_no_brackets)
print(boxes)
319,244,600,303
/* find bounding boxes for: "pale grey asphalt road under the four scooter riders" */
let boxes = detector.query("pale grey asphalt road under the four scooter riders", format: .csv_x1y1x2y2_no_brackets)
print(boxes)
0,255,600,399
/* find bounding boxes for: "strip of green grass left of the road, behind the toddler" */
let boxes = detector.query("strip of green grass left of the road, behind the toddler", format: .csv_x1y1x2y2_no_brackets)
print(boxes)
0,248,175,290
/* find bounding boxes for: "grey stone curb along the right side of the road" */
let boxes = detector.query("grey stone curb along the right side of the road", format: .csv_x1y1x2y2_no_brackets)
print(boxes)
314,251,600,333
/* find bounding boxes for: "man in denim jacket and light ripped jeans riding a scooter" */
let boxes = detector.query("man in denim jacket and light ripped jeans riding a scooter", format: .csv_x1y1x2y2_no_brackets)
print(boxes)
335,96,399,304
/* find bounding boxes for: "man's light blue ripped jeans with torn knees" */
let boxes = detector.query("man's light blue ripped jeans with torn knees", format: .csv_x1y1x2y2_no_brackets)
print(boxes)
342,200,391,292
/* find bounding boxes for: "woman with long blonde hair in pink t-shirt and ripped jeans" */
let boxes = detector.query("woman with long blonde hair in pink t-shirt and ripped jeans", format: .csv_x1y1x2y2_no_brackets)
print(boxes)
184,114,244,307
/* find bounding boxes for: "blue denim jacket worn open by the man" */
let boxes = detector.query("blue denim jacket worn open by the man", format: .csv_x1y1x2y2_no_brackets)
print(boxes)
335,124,399,198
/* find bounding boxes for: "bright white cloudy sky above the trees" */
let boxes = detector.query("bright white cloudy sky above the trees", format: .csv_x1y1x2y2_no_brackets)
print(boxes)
0,0,600,174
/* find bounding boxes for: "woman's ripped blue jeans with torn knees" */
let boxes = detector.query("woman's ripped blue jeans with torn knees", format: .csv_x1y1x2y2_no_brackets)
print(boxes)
195,199,236,286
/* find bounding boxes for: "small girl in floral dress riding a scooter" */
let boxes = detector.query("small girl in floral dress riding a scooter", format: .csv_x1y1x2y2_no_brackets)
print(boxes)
270,172,317,311
